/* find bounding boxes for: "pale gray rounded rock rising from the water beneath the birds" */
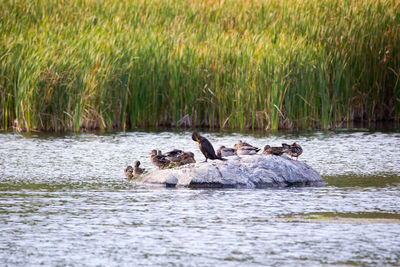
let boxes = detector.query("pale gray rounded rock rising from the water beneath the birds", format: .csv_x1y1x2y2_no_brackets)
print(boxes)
137,155,326,188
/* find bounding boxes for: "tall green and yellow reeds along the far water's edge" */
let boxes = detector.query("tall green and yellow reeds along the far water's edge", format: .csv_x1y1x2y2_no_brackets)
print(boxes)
0,0,400,132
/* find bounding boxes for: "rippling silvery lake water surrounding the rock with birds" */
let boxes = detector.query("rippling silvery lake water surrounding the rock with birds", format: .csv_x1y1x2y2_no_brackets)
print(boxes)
0,130,400,266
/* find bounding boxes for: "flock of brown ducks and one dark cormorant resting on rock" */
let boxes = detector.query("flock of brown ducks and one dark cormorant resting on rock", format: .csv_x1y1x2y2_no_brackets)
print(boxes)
125,132,303,181
